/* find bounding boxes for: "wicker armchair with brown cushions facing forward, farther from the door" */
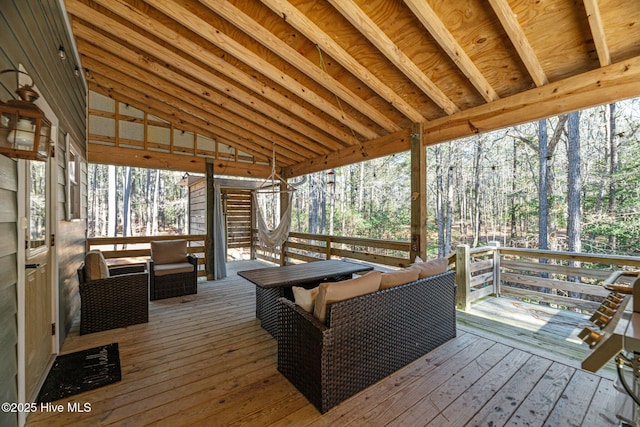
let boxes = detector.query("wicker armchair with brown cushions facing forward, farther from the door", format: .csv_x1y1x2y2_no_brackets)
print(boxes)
147,240,198,300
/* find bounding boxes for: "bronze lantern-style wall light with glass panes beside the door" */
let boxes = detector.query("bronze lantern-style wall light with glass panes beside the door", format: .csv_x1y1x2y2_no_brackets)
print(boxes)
0,70,51,160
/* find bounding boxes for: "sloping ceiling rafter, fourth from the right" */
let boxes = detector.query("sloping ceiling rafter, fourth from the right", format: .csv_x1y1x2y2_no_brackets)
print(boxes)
328,0,460,114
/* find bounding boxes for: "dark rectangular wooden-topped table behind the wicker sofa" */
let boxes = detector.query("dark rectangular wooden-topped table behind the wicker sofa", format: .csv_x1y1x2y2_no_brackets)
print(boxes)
238,260,373,337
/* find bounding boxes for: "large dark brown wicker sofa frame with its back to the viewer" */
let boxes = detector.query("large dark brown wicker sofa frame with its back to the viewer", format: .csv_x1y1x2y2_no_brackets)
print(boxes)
277,272,456,413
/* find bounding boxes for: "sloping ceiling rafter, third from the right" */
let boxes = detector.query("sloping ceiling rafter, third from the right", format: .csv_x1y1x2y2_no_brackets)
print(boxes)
404,0,500,102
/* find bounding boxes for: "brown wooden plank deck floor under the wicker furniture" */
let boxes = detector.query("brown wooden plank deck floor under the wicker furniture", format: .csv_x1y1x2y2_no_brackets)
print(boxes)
27,261,618,427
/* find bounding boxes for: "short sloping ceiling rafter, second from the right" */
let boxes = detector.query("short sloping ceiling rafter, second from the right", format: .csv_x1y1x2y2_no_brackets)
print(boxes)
489,0,549,86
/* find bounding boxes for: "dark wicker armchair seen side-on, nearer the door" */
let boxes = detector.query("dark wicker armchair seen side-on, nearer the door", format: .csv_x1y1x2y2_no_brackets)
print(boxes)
78,252,149,335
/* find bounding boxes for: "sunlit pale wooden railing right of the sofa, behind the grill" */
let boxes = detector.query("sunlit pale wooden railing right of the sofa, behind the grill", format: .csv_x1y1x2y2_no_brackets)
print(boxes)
456,243,640,313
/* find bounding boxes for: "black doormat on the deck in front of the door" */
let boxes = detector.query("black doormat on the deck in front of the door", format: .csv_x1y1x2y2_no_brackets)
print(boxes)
38,343,122,403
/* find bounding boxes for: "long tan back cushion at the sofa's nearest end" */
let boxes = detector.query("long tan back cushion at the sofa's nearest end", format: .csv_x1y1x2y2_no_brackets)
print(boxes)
313,271,382,323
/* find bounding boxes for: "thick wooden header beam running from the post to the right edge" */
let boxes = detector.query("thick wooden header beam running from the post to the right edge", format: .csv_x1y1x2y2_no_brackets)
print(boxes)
424,56,640,145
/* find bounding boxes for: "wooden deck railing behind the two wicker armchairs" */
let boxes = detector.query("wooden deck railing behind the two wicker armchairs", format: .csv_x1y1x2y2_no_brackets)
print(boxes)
87,234,206,276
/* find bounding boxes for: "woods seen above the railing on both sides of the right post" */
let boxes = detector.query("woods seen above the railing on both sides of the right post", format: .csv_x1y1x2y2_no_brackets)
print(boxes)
291,99,640,255
